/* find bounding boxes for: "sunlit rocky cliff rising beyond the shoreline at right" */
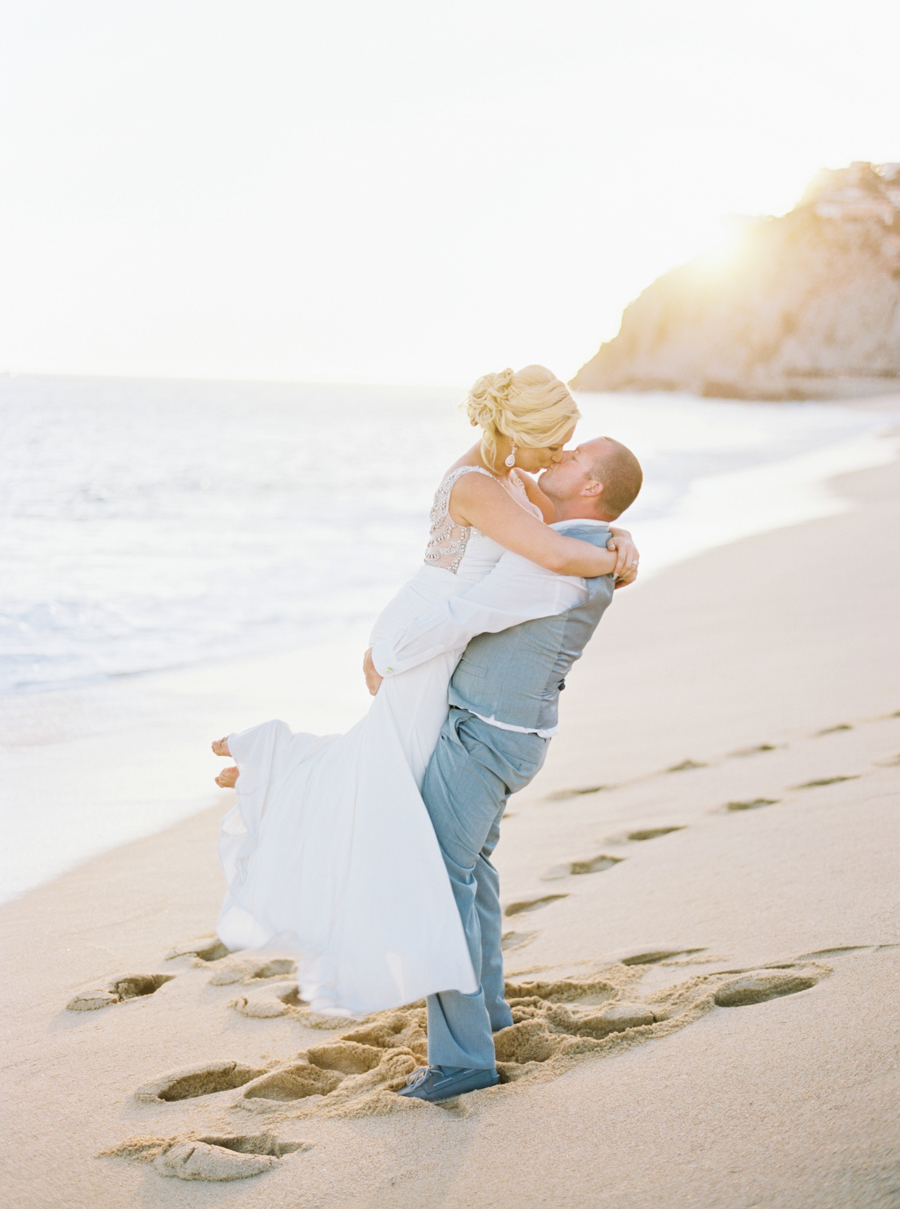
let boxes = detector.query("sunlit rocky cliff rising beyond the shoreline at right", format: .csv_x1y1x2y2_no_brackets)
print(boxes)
571,163,900,399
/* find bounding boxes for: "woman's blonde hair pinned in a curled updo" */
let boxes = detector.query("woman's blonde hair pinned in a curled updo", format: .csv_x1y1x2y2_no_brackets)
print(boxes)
465,365,581,467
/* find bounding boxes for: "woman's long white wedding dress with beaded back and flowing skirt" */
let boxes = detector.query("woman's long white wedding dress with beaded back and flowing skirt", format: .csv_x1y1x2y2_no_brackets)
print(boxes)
217,467,533,1014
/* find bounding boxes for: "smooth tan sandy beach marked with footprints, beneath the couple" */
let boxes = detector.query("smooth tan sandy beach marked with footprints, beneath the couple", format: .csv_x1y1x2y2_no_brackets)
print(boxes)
0,400,900,1209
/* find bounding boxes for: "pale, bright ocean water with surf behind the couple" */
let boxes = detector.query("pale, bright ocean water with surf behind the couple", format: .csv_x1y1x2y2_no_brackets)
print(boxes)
0,377,900,899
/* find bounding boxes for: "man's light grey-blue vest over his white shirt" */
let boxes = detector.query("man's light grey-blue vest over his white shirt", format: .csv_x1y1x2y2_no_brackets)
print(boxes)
450,525,615,730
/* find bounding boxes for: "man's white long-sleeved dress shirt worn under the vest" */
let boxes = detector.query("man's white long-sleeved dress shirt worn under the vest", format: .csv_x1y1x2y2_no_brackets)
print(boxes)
371,517,605,739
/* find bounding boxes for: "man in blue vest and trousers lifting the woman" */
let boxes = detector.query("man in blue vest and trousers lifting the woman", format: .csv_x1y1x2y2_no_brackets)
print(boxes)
367,436,642,1100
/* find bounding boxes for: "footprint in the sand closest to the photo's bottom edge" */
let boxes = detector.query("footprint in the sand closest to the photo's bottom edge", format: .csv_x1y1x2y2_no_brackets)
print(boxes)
98,1133,302,1181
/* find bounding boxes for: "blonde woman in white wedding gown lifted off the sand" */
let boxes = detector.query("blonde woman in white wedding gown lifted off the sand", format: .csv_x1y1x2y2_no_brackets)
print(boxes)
213,365,636,1014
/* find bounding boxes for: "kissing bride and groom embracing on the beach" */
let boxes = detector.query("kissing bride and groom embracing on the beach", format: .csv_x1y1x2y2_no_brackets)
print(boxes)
213,365,642,1100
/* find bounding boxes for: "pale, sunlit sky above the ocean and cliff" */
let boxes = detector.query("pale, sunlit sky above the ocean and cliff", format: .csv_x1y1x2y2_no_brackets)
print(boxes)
0,0,900,384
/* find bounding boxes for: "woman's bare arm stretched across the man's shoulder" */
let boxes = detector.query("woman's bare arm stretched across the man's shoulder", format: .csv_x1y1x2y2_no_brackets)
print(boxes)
450,474,617,579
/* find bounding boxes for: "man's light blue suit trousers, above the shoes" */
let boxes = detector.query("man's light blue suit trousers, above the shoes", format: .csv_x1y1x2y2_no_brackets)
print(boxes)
422,707,549,1069
